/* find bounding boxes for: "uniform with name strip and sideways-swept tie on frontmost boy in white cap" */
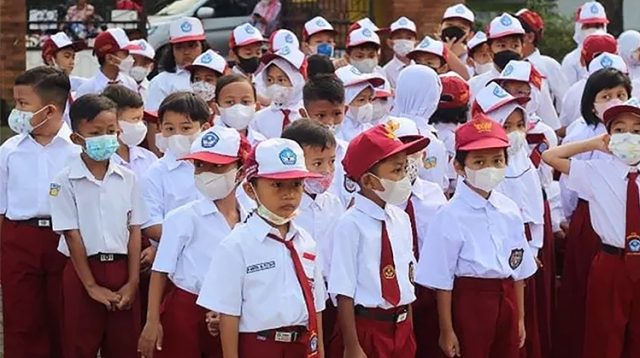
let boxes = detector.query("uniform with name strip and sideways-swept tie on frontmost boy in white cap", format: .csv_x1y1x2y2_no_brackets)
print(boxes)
197,214,326,358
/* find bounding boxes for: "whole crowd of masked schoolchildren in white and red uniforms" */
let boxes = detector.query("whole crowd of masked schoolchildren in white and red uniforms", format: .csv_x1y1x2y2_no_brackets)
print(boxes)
0,2,640,358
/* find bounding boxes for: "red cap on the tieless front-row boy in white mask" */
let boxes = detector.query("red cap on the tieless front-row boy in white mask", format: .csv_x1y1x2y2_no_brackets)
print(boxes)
456,114,509,151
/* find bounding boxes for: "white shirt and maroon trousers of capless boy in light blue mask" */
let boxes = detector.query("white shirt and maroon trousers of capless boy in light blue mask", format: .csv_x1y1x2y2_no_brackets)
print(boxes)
50,155,147,358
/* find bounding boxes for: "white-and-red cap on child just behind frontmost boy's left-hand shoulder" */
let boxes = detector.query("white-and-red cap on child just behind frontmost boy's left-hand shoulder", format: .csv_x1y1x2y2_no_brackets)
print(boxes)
180,126,251,165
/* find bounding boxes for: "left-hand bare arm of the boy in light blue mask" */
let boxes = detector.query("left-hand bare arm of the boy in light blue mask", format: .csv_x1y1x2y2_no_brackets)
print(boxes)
64,230,120,311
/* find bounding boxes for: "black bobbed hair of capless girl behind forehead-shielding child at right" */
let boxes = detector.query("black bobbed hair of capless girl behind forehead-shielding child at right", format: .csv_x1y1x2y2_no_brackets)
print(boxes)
580,68,631,126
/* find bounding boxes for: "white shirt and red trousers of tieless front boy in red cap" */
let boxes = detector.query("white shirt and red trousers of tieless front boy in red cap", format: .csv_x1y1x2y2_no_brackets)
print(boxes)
416,180,536,357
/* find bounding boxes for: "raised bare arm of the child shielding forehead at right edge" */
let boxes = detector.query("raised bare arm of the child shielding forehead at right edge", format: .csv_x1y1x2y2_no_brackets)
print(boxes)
542,134,610,174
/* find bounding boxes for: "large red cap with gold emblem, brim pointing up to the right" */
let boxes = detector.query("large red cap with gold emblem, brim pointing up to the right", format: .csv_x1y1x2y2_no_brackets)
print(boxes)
342,120,428,182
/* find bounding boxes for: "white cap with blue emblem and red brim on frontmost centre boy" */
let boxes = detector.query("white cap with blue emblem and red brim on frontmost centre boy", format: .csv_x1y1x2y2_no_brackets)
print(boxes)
245,138,321,181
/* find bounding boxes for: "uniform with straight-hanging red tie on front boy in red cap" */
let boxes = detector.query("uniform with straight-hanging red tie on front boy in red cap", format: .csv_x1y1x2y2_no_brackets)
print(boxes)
329,194,416,357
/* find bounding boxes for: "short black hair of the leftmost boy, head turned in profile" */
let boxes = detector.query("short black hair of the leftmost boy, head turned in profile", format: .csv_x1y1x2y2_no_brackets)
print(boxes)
14,66,71,113
